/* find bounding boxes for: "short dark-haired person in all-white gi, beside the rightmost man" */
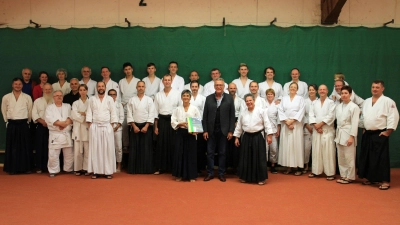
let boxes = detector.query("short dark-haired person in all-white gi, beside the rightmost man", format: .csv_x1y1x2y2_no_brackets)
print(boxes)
335,86,360,184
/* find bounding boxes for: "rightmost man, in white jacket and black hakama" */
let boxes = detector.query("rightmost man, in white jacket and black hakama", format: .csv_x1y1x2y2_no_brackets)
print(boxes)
358,80,399,190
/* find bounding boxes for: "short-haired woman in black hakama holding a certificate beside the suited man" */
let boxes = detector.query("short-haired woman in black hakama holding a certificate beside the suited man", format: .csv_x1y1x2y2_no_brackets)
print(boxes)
171,90,201,182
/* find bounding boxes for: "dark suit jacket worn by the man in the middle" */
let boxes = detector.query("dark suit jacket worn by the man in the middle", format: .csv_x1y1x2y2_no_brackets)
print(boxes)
202,93,235,136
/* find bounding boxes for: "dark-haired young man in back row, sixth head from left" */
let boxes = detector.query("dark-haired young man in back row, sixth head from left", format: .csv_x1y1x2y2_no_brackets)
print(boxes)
119,62,140,152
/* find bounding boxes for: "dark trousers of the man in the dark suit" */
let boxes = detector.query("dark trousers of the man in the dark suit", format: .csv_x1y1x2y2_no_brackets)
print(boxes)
207,131,227,176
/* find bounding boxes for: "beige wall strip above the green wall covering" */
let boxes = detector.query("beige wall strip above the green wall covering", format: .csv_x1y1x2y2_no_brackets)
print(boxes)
0,0,400,28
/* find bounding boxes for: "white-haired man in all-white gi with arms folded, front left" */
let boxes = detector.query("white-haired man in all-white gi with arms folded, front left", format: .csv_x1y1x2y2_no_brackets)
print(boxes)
45,90,74,177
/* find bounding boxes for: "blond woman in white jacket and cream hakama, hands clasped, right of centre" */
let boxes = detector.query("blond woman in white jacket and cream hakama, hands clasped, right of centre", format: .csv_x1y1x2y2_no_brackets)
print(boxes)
278,82,305,176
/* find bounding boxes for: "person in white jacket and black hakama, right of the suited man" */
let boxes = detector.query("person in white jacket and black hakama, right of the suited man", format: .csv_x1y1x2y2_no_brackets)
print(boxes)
233,94,273,185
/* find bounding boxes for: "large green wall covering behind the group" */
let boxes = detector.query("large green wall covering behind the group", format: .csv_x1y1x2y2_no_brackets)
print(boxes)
0,26,400,167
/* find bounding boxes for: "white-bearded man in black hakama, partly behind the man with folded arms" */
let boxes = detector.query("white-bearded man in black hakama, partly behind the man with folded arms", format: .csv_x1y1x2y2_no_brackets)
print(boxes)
32,83,53,173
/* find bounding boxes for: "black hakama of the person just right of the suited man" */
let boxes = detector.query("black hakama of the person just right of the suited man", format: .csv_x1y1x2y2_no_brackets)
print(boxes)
238,131,268,183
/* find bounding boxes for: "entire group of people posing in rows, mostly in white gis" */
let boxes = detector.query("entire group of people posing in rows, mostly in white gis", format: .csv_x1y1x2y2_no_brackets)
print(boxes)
2,62,399,190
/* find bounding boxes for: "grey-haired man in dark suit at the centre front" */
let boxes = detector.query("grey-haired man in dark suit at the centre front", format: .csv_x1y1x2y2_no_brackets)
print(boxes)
203,74,235,182
